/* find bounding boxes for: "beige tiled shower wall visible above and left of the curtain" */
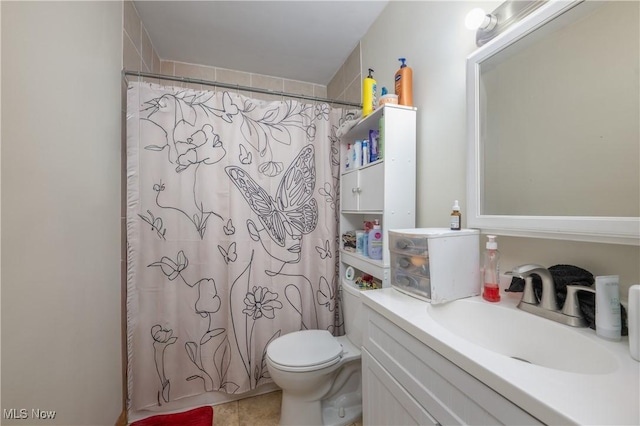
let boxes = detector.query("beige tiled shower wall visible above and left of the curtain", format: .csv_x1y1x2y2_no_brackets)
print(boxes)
120,0,362,418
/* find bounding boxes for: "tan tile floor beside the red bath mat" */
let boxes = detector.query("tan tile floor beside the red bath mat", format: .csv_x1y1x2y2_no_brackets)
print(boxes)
213,391,362,426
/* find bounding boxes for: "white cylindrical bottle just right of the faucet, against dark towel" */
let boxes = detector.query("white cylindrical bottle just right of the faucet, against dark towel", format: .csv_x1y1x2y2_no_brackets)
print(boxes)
596,275,622,340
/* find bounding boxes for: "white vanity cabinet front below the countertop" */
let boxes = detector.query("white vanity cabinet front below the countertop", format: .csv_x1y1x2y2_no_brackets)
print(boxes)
362,305,542,425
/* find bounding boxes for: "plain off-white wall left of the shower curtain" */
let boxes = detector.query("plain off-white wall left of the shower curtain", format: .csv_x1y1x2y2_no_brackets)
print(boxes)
1,1,122,425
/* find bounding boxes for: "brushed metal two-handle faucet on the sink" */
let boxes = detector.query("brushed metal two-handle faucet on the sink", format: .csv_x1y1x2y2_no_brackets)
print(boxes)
507,264,594,327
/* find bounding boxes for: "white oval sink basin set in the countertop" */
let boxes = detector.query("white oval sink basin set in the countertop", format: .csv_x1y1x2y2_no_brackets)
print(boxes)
427,297,618,374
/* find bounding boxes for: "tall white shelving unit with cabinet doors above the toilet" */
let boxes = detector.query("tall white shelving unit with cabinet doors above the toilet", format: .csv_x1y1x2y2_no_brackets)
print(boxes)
340,104,416,287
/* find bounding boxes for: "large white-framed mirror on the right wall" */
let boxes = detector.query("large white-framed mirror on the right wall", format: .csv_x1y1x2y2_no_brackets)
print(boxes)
467,1,640,245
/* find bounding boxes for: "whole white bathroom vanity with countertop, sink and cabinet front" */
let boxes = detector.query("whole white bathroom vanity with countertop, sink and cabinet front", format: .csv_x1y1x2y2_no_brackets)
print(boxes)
362,288,640,425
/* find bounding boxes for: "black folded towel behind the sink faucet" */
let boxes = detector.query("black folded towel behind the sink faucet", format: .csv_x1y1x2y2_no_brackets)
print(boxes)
506,265,628,336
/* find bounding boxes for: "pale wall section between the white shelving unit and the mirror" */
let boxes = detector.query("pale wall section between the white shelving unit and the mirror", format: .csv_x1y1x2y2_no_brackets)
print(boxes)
362,1,500,227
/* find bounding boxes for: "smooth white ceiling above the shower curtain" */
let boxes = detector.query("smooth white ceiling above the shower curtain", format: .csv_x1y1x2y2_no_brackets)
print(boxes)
134,0,387,85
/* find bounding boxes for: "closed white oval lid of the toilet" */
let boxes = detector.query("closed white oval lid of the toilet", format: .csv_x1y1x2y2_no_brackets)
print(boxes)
267,330,342,371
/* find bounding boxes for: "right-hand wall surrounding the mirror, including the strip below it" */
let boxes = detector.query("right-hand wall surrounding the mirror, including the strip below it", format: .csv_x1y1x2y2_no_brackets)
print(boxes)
361,1,640,299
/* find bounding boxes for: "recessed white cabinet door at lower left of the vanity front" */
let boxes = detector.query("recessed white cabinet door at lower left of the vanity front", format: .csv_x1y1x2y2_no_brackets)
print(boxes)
362,349,439,426
